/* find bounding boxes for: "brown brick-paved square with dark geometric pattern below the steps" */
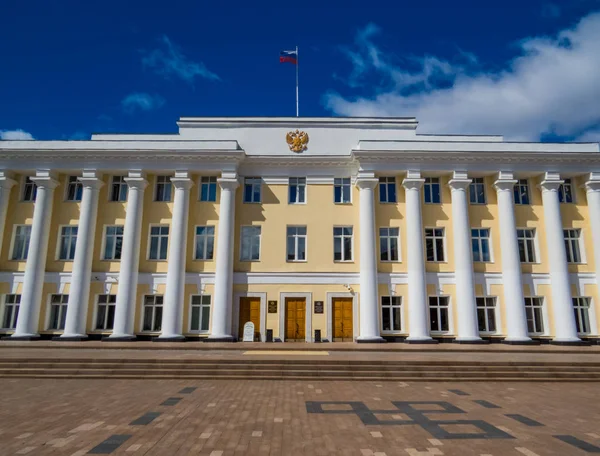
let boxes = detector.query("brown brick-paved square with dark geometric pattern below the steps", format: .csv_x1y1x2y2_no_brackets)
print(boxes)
0,379,600,456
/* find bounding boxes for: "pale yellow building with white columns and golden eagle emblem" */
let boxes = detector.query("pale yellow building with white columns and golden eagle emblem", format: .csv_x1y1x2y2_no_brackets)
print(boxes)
0,117,600,343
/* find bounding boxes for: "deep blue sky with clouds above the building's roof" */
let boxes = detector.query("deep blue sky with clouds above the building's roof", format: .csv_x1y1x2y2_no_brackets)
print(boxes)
0,0,600,141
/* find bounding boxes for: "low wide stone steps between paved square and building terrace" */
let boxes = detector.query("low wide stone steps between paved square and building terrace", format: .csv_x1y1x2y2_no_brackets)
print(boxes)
0,357,600,382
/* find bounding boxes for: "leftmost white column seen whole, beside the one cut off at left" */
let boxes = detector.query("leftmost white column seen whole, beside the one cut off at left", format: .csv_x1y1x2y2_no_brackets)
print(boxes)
11,171,58,339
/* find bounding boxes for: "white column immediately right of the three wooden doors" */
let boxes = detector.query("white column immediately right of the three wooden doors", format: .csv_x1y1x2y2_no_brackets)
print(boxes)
356,177,383,343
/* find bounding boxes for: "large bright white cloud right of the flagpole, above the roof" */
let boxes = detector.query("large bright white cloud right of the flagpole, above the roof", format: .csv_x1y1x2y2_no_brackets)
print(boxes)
324,13,600,140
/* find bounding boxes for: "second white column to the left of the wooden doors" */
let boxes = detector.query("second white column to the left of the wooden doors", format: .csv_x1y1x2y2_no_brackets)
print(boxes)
158,172,194,341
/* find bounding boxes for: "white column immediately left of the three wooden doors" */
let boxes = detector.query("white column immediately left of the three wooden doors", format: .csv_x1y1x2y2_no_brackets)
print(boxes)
209,175,239,341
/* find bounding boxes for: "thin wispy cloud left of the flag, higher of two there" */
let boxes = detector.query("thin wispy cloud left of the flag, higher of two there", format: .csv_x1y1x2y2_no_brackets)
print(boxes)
142,35,220,83
